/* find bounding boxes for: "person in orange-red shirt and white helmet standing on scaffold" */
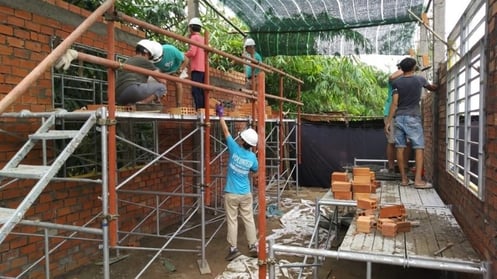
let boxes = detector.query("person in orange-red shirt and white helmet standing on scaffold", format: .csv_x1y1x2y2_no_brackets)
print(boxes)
181,17,205,110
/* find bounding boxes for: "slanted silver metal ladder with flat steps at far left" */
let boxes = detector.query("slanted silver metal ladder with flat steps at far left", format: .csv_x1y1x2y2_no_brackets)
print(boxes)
0,113,97,244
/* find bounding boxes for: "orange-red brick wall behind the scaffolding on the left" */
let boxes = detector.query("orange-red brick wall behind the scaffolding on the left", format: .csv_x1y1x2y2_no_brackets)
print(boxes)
0,0,245,278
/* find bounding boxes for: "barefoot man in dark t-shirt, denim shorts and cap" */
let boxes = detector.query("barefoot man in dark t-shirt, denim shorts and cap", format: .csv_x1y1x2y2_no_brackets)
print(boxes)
385,57,437,189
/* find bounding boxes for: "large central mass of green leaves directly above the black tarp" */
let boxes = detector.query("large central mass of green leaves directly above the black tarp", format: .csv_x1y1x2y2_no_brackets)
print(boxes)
265,56,388,116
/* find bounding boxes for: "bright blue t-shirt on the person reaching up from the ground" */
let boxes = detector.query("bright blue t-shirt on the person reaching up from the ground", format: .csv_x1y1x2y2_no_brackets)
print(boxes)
224,136,259,195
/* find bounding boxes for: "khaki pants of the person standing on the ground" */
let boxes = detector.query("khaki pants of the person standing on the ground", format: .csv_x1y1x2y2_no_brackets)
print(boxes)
224,193,257,247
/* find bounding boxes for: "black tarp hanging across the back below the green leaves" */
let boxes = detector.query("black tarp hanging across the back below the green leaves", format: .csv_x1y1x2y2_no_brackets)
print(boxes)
299,119,387,187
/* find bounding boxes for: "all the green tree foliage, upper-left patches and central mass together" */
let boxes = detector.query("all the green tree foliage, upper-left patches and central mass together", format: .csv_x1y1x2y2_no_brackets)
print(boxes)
68,0,388,116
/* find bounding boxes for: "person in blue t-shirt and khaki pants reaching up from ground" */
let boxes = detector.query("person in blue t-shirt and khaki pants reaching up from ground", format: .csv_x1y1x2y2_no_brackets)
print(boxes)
217,110,259,261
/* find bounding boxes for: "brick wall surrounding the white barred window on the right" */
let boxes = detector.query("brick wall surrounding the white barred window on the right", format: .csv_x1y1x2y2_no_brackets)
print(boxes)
423,0,497,274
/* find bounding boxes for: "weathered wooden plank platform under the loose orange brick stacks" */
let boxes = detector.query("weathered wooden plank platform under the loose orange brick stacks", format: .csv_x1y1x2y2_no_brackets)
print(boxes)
321,181,481,272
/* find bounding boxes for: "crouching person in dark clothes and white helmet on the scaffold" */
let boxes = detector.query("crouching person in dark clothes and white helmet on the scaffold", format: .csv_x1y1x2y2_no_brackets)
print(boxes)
116,39,167,105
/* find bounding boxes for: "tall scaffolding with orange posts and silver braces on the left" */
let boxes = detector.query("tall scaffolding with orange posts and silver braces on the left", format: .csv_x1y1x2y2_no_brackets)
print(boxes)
0,0,302,278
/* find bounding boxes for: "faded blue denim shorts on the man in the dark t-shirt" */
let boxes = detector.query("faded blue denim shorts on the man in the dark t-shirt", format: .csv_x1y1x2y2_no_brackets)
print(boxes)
394,115,425,149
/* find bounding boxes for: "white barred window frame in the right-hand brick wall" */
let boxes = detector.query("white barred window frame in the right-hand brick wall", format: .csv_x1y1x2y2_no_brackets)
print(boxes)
445,0,488,199
